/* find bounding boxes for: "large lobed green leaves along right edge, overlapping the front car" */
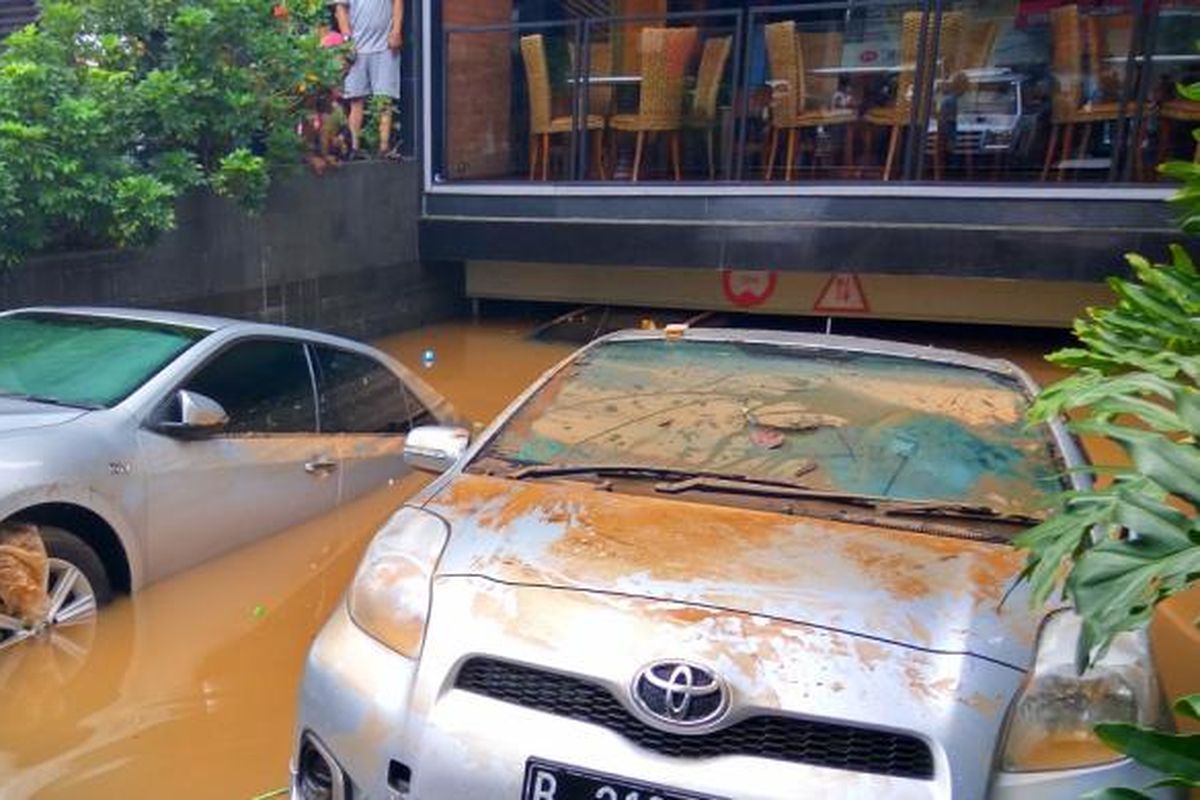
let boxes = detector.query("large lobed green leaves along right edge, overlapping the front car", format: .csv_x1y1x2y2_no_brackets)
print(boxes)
1016,77,1200,800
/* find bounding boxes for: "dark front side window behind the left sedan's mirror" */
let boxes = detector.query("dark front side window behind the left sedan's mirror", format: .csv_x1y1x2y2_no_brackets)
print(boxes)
184,339,317,433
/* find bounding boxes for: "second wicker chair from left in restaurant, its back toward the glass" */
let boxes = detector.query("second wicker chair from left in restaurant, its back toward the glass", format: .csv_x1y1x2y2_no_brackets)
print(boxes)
608,28,698,181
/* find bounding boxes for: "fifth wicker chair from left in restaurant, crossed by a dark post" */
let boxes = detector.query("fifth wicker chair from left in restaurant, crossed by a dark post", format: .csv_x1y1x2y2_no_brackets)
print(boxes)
864,11,964,181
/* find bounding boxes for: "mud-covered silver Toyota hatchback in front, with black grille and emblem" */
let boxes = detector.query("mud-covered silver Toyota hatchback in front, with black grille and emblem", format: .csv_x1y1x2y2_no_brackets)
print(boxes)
293,330,1170,800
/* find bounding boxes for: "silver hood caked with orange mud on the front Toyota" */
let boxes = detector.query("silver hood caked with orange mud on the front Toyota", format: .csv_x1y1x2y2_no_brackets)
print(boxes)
426,475,1040,669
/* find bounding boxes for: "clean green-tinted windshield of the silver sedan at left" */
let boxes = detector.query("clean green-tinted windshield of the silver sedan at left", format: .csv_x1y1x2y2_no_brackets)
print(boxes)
0,313,208,408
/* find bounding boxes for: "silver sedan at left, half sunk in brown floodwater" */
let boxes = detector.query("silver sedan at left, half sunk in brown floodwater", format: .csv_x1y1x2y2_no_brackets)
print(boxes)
0,308,452,650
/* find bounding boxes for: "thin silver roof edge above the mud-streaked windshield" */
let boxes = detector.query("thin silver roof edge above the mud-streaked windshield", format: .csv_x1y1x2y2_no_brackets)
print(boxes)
592,327,1037,387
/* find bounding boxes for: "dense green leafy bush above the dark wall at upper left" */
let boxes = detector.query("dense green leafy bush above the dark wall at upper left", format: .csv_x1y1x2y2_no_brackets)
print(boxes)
0,0,341,263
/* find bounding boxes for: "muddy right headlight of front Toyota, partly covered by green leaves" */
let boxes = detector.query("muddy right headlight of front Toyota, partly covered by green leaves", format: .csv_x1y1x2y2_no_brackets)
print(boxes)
1003,610,1164,772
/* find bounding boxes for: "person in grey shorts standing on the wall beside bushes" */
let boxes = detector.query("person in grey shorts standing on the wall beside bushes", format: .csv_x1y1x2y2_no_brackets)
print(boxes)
334,0,404,157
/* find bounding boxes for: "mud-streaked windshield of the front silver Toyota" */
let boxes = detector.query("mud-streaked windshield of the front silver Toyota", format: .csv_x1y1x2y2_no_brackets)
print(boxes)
472,339,1061,515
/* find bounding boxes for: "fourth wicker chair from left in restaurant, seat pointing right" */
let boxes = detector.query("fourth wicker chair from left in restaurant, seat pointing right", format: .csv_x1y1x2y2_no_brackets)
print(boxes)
763,20,854,181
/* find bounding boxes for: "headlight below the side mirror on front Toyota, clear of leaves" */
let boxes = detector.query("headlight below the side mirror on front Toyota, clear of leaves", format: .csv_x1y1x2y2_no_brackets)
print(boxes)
347,506,449,658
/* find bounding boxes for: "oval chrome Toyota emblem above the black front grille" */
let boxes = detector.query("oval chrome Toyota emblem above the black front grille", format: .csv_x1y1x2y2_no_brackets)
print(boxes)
632,661,728,727
